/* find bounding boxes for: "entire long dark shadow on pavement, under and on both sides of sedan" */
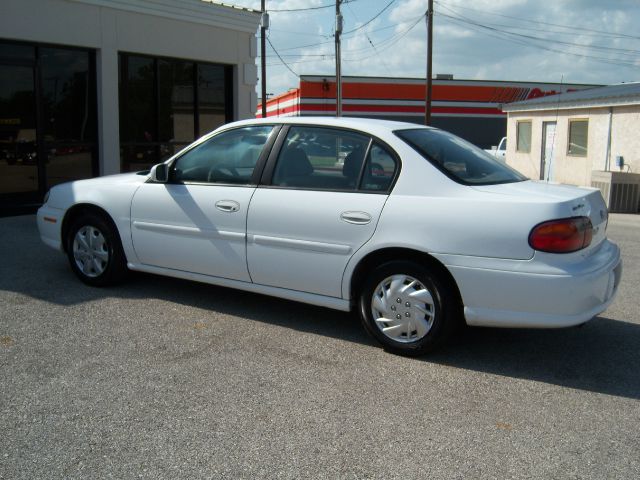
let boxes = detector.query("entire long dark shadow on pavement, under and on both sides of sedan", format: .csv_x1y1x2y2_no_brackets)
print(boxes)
0,217,640,399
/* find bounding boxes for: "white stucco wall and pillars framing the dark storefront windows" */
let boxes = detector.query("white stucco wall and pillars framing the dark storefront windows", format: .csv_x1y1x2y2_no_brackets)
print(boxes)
0,0,259,175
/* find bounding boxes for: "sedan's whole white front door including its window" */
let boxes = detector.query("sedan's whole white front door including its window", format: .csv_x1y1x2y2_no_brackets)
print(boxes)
131,126,275,281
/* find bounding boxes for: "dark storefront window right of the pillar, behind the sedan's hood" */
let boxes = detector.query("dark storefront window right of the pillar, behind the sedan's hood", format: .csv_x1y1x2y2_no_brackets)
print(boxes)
119,53,232,171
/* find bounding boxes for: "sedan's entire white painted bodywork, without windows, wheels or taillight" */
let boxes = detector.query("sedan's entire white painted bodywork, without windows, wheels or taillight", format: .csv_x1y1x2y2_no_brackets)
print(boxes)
38,117,622,327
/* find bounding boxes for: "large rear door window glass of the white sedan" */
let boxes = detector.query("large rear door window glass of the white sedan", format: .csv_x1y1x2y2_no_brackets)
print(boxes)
273,127,369,190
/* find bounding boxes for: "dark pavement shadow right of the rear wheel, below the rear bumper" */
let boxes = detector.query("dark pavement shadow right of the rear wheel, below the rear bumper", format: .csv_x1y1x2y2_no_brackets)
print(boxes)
424,317,640,399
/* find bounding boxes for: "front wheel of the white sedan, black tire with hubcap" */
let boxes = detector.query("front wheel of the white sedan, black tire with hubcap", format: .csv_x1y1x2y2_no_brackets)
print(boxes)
66,212,128,287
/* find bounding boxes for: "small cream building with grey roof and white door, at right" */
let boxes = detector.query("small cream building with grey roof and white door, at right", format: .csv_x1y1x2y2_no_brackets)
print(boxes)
503,82,640,212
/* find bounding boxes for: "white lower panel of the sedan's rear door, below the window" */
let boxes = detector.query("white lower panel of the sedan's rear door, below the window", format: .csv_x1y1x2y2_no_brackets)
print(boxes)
247,188,387,298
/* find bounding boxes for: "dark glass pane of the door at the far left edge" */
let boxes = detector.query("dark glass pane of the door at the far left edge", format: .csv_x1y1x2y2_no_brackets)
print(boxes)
0,64,39,197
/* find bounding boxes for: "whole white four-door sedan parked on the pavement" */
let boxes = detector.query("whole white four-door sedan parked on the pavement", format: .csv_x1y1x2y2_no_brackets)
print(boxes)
38,118,622,355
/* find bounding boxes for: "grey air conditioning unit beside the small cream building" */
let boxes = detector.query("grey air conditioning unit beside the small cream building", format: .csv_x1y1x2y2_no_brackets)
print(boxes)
591,170,640,213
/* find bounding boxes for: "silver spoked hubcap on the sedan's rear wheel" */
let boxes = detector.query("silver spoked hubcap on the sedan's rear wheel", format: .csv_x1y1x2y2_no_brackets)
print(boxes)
371,275,435,343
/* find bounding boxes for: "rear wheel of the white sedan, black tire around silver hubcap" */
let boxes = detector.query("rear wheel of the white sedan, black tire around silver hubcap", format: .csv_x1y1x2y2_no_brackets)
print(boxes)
358,261,462,356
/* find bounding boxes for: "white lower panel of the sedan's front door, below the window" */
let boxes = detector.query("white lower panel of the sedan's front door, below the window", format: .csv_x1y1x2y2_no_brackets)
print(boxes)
131,183,255,282
